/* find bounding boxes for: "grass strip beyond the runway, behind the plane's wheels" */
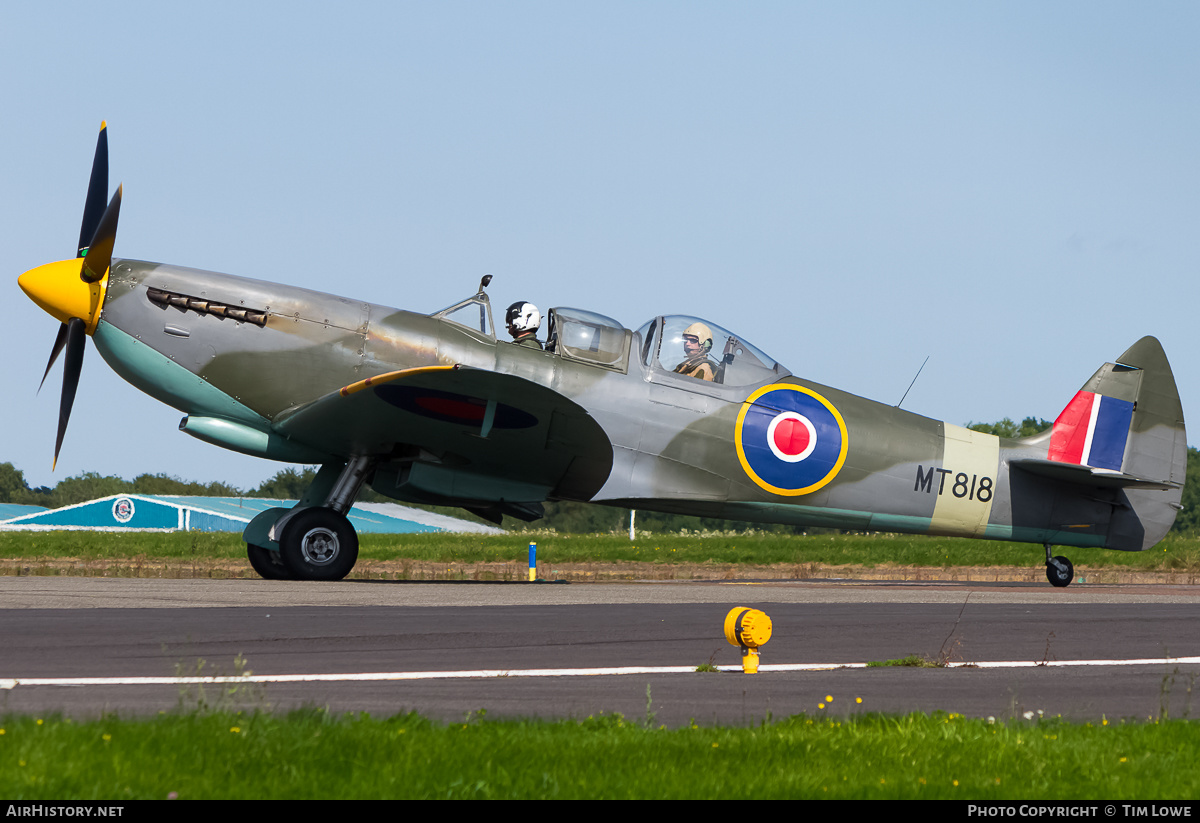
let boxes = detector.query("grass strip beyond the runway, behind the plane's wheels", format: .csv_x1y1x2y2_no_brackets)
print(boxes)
0,531,1200,571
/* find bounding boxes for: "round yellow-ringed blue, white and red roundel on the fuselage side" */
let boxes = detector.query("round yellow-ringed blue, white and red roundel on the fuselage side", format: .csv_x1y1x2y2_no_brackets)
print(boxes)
733,384,850,495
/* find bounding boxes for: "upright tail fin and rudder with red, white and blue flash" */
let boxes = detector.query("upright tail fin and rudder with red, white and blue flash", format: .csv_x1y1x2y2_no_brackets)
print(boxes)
1046,337,1188,551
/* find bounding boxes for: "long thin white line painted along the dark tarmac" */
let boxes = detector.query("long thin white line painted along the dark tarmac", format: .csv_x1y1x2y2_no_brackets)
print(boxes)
0,657,1200,689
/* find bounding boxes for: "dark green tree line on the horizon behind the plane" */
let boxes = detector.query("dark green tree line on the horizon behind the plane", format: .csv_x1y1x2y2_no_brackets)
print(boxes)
0,417,1200,534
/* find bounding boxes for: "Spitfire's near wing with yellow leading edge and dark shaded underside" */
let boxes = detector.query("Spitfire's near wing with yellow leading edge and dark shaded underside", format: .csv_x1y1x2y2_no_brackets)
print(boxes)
275,366,612,499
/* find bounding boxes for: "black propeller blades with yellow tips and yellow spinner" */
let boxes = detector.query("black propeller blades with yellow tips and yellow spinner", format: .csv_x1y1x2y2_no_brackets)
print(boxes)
28,124,121,465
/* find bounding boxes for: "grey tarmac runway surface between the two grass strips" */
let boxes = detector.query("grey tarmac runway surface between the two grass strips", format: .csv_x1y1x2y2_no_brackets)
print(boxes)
0,577,1200,726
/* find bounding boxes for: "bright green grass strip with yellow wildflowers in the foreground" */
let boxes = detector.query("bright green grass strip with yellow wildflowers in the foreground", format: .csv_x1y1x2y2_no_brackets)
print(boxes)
0,710,1200,801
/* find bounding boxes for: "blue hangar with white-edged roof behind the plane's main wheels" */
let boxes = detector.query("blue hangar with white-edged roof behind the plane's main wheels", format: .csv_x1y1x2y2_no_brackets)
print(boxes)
0,494,503,534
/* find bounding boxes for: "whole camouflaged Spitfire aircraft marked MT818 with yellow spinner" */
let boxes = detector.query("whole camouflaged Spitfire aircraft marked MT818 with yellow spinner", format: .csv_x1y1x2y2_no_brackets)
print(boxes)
19,127,1187,587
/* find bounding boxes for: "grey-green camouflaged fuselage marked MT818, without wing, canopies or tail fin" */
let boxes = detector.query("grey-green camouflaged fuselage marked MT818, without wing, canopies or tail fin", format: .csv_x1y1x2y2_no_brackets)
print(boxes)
65,260,1180,548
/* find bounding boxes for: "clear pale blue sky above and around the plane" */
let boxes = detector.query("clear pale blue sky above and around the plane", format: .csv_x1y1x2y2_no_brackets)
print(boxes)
0,0,1200,487
